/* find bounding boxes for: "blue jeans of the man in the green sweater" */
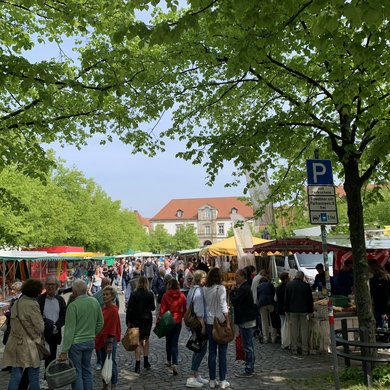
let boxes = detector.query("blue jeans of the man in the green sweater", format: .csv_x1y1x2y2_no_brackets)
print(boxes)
69,340,94,390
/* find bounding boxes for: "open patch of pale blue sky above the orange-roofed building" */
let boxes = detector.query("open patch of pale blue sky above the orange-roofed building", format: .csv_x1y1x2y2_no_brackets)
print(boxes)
49,138,245,218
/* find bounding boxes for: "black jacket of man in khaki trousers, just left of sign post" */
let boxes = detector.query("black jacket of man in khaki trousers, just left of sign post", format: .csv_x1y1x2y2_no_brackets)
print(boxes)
284,278,314,313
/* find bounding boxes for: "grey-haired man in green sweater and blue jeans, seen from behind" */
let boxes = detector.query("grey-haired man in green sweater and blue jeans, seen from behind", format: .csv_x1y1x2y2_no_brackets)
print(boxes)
58,279,103,390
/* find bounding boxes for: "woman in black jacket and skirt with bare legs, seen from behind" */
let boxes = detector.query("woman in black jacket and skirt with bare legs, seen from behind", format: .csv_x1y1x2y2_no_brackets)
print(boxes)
126,276,156,374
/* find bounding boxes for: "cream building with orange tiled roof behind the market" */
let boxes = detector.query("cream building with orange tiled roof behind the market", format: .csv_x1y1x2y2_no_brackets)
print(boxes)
150,197,253,246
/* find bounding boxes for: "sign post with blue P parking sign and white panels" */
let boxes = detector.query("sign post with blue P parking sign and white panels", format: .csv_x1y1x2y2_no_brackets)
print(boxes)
306,150,340,390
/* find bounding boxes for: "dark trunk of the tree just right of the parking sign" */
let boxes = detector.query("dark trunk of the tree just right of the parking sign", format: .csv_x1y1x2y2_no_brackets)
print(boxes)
343,155,375,342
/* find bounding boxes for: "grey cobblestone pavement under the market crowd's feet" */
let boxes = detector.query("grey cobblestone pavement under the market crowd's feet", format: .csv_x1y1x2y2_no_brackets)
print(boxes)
0,295,332,390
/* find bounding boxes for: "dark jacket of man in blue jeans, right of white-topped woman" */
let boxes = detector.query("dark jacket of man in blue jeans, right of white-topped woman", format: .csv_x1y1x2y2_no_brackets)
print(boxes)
230,282,257,325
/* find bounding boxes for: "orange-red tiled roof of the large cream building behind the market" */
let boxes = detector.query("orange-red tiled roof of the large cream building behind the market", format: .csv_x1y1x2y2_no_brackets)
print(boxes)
150,196,253,221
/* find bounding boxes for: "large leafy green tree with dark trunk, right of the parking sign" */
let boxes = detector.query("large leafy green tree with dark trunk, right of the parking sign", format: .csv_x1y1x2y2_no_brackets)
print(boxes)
122,0,390,338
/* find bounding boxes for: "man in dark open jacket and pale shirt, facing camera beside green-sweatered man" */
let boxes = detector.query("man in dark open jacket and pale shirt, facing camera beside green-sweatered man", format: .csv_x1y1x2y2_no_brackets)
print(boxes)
37,275,66,388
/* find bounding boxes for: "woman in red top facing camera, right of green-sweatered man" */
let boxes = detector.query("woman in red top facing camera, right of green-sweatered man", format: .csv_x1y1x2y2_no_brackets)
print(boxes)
95,286,121,390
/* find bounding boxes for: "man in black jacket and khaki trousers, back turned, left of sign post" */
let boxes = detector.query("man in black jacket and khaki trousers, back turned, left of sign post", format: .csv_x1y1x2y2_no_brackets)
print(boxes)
284,271,314,355
